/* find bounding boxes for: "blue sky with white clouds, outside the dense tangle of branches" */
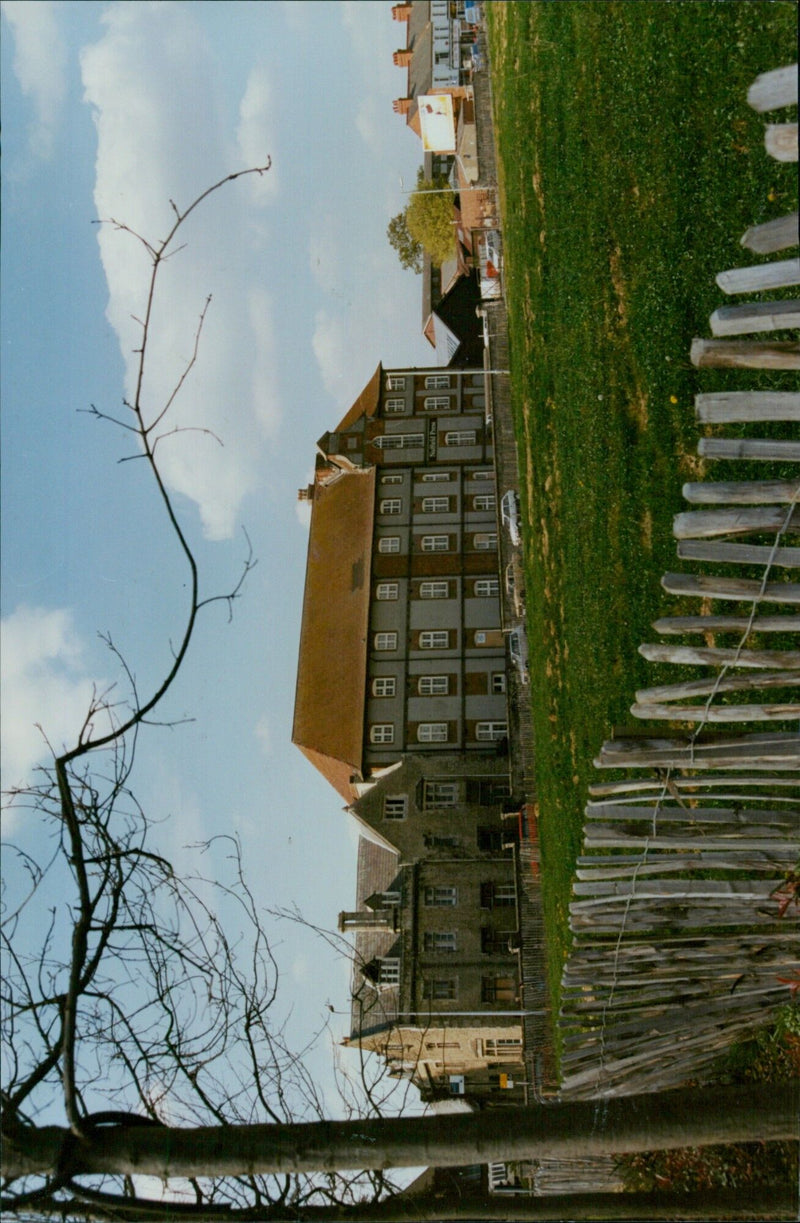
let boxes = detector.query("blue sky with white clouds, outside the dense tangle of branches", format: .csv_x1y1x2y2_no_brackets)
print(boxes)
0,0,433,1120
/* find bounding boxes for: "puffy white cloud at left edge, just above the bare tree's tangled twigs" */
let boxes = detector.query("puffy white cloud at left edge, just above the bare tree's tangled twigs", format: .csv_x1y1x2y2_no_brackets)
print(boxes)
0,607,105,788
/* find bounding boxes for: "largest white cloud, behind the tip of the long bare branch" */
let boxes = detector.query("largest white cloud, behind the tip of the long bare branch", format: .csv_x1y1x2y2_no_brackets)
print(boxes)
81,2,281,539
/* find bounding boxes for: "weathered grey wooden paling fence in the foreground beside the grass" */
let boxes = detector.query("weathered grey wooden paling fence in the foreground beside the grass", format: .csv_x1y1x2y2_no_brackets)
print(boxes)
559,65,800,1098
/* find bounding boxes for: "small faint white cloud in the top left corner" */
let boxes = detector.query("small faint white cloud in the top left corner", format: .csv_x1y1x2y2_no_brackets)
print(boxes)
2,0,67,160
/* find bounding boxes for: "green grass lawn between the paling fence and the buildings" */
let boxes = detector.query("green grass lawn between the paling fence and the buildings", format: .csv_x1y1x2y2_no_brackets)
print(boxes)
487,0,796,1022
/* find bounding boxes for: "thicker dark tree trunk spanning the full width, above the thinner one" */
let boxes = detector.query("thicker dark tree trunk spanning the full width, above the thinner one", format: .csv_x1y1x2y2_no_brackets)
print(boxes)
2,1084,800,1180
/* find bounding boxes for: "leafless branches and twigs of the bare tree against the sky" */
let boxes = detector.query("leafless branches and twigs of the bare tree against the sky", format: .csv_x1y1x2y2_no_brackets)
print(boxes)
0,172,398,1213
